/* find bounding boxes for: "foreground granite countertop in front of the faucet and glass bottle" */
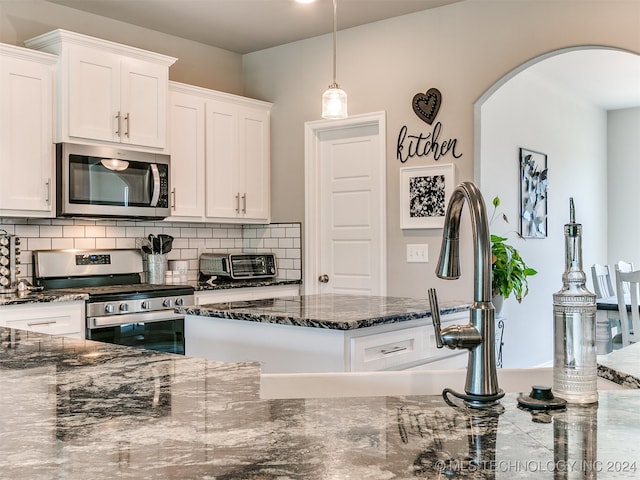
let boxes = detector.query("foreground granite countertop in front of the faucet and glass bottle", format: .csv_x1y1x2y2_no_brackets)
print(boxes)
0,328,640,480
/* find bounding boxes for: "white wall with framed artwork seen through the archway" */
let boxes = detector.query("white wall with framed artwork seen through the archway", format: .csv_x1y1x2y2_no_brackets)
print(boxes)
480,62,607,368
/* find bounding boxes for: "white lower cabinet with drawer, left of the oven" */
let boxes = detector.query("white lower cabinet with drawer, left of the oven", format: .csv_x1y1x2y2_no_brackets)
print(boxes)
0,301,85,338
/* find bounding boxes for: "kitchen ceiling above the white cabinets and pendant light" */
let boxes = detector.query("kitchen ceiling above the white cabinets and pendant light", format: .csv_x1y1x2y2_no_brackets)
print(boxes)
47,0,462,54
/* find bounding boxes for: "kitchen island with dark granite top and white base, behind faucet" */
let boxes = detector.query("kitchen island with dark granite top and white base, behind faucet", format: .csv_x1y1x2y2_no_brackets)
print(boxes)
175,294,469,373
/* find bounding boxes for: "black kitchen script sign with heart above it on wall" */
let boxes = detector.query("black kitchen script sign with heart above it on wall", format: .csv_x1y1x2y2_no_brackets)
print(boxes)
396,88,462,163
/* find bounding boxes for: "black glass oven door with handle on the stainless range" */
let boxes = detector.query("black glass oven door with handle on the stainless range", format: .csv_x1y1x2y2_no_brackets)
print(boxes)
87,311,184,355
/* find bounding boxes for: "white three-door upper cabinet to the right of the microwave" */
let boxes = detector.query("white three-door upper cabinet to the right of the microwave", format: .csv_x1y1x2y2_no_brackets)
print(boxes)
169,82,271,223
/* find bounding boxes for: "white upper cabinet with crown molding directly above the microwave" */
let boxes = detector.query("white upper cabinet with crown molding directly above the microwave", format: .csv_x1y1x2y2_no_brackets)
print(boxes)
25,30,176,149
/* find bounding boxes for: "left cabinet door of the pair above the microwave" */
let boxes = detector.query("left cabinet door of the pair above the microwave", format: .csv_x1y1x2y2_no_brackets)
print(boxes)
63,48,125,142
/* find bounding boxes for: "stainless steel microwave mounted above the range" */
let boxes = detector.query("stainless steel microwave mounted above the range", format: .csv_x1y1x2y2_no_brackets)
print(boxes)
56,143,170,220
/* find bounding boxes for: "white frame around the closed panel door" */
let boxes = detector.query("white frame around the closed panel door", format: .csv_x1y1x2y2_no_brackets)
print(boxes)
303,111,387,295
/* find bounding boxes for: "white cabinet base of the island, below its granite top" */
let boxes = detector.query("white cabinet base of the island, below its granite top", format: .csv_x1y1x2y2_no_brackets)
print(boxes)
185,312,468,373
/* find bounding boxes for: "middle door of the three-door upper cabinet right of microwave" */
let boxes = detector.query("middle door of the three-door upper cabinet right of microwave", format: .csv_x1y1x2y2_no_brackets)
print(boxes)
205,101,243,218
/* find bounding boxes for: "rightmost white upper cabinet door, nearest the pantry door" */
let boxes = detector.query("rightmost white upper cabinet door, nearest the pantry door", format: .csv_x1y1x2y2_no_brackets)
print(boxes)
239,108,271,223
